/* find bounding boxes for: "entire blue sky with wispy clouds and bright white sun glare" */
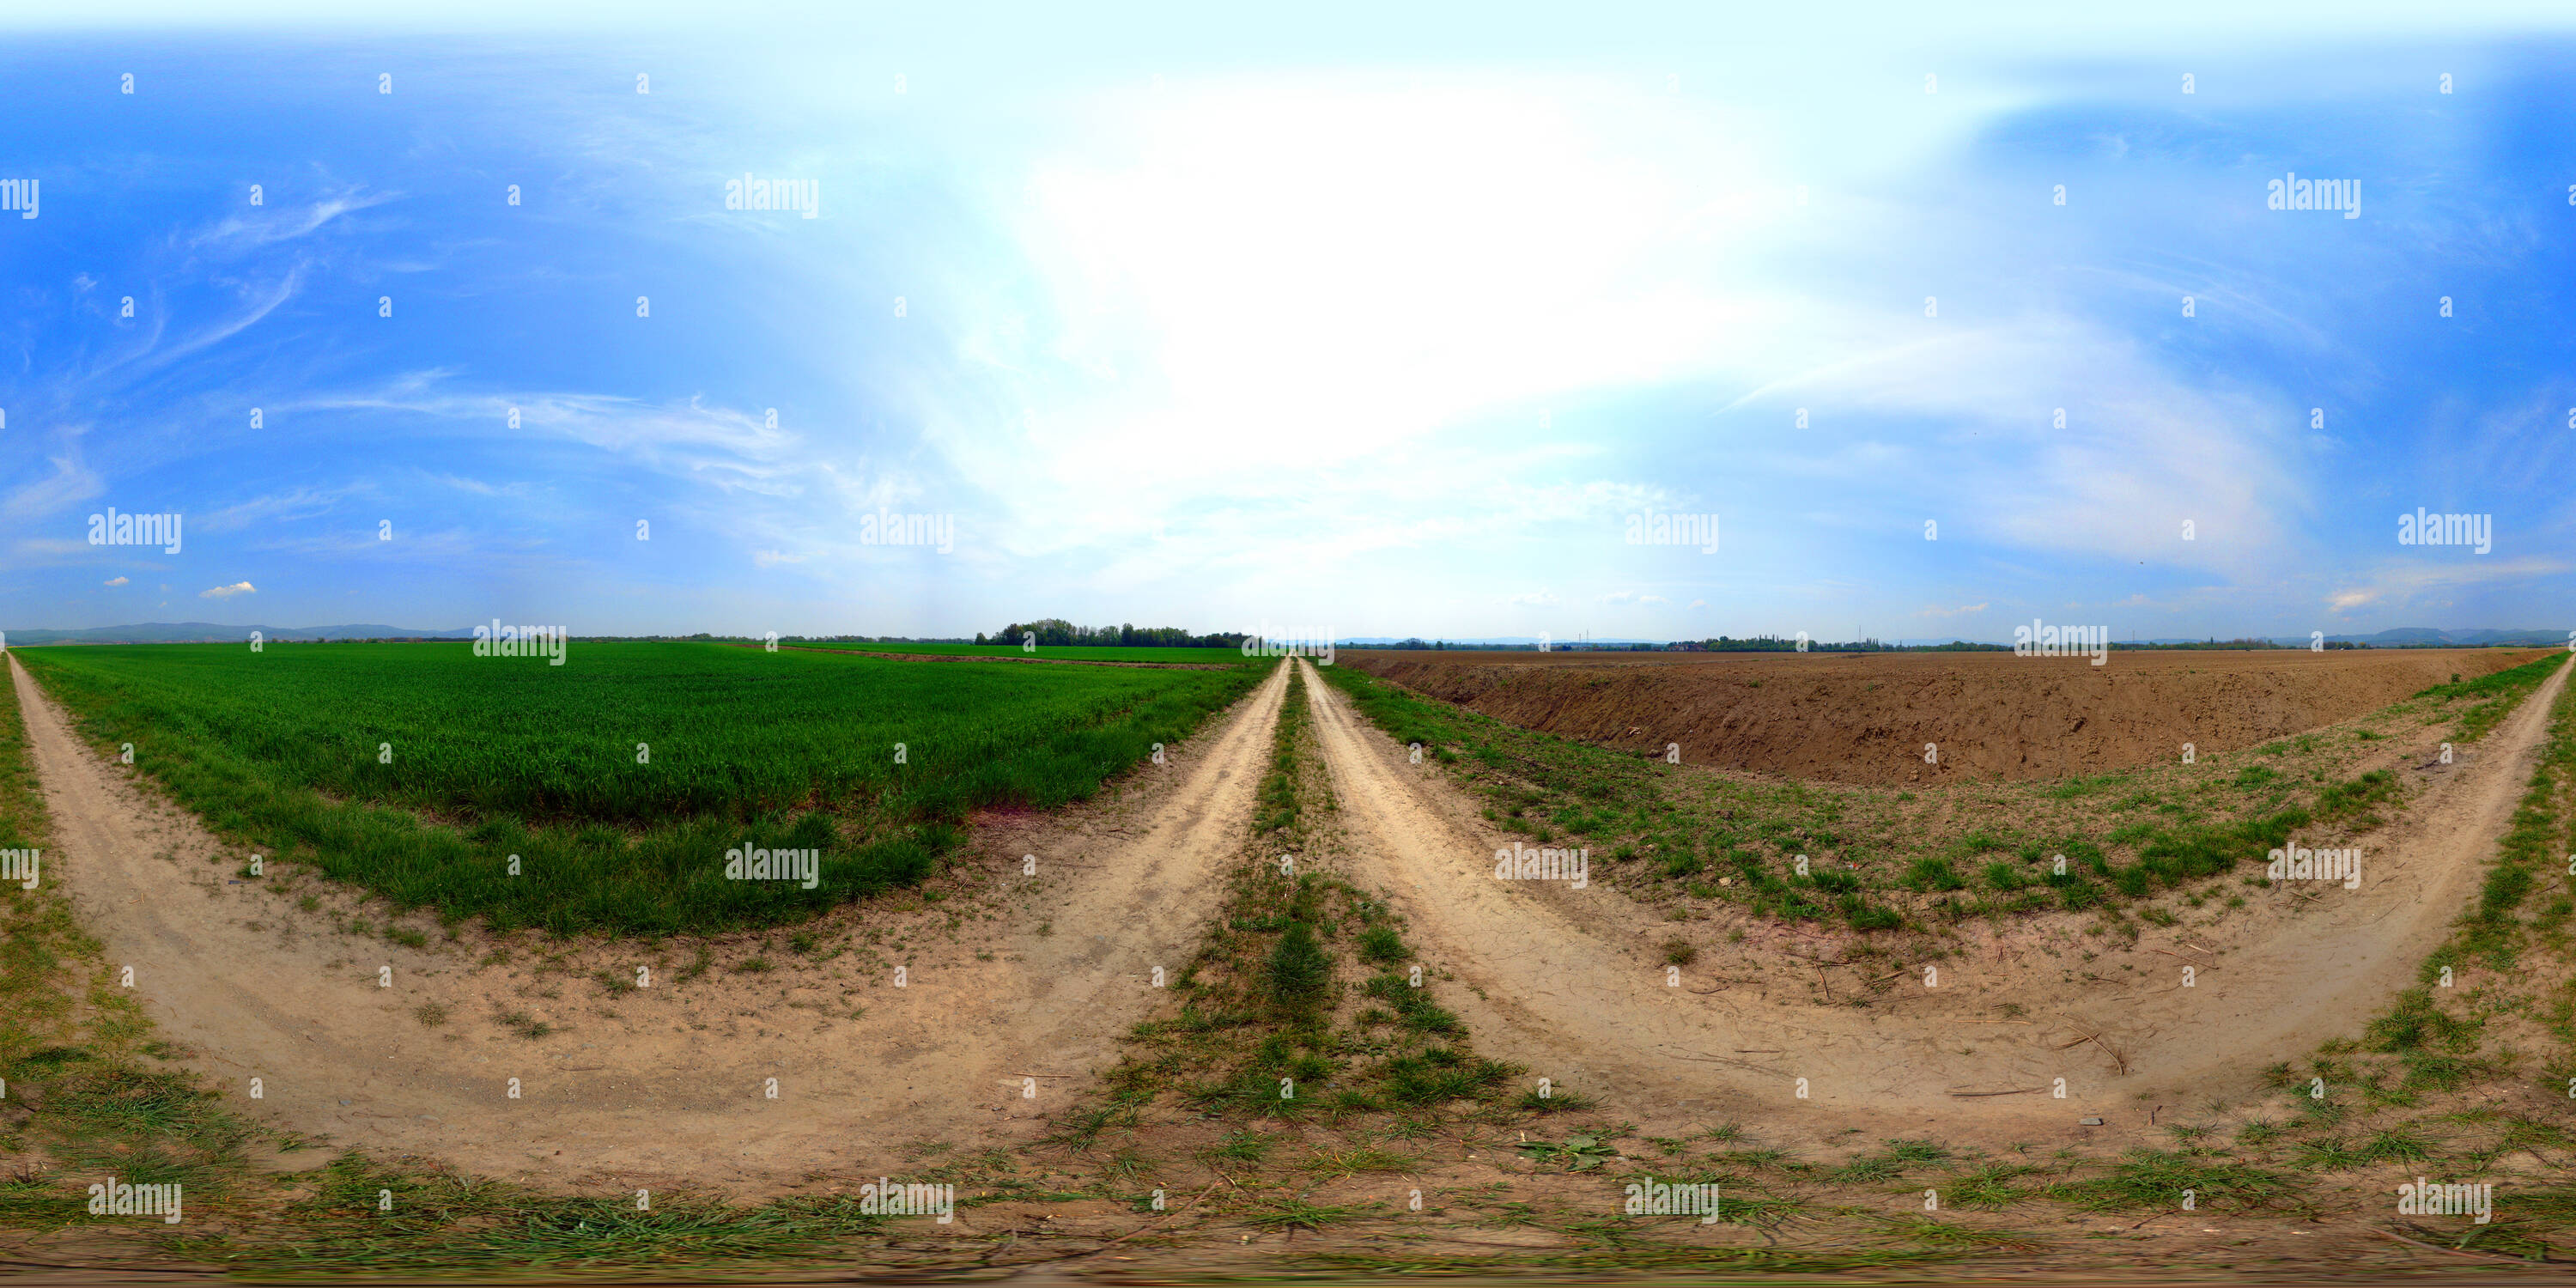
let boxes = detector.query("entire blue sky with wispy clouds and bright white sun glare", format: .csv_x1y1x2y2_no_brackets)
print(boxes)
0,0,2576,639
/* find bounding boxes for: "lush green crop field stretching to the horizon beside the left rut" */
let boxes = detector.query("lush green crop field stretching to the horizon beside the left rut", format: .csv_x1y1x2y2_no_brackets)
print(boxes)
15,641,1265,933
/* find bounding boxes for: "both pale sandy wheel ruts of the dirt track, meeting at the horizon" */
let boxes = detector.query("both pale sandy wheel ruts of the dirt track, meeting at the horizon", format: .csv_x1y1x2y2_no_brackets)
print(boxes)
13,644,2566,1188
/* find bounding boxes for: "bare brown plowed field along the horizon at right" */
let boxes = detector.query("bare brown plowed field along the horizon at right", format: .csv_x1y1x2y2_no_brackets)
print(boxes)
1337,649,2545,783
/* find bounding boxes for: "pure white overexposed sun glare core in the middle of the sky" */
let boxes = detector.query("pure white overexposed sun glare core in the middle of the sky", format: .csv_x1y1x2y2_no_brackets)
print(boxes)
1025,75,1790,464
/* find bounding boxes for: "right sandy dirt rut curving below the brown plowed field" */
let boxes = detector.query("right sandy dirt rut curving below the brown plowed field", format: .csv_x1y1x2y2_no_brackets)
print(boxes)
1298,662,2566,1139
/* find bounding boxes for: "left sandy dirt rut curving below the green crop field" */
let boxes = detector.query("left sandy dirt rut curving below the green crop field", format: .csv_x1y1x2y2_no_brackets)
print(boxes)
10,649,1288,1193
